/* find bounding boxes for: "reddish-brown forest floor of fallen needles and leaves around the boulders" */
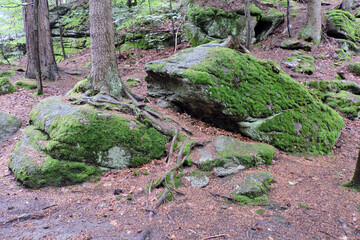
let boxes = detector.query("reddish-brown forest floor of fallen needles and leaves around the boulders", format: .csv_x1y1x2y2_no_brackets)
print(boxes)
0,0,360,239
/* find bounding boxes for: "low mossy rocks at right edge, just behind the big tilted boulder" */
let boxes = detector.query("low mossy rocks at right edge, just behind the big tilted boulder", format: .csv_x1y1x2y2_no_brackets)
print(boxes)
308,81,360,120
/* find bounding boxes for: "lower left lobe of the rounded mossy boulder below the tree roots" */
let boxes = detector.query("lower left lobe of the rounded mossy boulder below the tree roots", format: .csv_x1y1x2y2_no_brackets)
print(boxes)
9,126,102,188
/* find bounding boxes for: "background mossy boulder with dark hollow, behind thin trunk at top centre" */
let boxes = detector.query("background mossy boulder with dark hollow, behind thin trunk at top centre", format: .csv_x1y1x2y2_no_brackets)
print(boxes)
185,5,284,46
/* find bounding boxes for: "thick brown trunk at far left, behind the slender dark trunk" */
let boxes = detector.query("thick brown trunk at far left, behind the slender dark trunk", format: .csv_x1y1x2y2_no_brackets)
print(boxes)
23,0,59,81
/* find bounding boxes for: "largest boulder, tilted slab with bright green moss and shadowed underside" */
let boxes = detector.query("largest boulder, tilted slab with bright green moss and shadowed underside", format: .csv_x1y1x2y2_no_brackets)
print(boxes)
146,46,344,154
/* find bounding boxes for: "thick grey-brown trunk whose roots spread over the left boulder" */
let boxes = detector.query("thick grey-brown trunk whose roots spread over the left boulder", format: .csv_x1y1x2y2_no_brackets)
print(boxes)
90,0,123,96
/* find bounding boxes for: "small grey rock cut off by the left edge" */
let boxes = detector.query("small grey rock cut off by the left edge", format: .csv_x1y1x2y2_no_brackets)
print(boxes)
0,111,21,143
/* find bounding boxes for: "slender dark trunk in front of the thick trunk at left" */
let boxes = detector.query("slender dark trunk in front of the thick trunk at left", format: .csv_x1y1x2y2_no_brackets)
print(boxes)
34,0,43,95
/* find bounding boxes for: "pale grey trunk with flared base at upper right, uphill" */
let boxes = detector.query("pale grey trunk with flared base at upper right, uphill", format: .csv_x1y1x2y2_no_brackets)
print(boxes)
299,0,321,45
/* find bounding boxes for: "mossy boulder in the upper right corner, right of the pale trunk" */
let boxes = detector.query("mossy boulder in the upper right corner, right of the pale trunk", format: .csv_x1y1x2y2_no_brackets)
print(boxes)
325,10,360,42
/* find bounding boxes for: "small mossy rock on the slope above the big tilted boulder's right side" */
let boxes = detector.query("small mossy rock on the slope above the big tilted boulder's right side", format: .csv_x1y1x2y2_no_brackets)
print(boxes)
285,51,315,75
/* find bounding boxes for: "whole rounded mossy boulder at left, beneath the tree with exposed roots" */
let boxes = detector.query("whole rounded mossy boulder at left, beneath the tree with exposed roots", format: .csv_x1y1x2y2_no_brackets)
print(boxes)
9,97,165,188
